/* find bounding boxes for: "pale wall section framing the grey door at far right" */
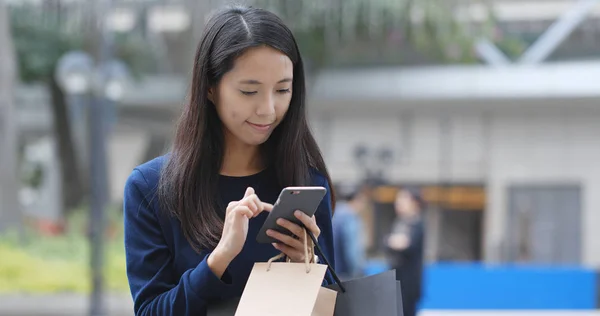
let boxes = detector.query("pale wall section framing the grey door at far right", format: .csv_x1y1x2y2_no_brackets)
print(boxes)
485,111,600,267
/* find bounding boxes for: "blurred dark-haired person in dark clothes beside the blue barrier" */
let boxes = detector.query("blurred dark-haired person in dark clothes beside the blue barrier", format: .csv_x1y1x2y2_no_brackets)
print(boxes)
387,189,425,316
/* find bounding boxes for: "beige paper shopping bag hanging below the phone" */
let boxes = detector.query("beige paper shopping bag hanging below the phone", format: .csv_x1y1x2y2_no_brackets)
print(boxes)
235,228,337,316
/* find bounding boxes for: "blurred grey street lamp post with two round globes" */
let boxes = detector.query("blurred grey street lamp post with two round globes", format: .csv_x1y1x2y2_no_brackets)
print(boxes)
56,52,129,316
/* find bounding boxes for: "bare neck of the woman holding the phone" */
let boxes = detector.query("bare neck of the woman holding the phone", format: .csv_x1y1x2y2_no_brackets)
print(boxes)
221,131,264,177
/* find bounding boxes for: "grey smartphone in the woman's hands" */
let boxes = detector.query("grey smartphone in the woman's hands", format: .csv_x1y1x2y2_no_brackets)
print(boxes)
256,186,327,244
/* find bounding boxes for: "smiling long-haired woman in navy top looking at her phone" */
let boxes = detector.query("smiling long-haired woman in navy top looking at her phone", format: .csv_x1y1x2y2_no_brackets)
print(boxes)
124,7,334,316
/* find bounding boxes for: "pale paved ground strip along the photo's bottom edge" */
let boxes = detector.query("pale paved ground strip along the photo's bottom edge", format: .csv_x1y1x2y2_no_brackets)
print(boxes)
0,294,600,316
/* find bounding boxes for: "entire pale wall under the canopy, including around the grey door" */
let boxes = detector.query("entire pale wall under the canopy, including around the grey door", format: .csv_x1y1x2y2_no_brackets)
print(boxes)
311,108,600,267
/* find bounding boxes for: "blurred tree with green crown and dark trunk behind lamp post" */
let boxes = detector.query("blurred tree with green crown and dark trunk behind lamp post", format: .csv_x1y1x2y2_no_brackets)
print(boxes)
10,1,154,216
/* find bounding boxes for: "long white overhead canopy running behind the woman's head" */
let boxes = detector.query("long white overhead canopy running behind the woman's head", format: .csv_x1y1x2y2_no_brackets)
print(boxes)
17,61,600,133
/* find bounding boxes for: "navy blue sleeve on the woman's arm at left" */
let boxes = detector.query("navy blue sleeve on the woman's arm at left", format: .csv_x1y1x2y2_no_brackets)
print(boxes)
123,169,231,316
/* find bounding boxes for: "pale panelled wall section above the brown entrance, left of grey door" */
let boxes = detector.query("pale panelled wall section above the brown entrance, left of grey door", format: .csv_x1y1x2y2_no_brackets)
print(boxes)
311,111,488,182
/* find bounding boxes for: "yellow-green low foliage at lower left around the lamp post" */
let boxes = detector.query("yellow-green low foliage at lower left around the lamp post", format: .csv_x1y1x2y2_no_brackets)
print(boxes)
0,207,129,294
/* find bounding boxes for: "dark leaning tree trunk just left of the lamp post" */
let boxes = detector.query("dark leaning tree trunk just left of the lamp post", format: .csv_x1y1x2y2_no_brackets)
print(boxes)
49,77,87,215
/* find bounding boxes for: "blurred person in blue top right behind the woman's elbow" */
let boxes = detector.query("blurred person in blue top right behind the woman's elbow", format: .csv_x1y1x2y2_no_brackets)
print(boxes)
332,184,369,279
